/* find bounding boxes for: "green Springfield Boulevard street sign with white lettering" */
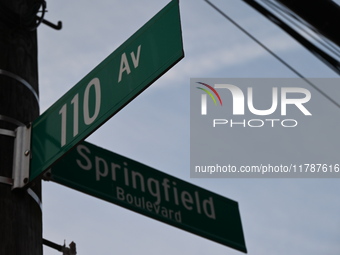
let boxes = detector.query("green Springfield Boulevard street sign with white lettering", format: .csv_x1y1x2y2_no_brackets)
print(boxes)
50,142,247,253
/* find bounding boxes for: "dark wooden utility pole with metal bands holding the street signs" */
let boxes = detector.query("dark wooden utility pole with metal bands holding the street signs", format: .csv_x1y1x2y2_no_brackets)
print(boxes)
0,0,43,255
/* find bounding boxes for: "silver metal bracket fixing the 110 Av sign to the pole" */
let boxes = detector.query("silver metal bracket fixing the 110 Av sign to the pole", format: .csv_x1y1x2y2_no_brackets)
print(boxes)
12,125,31,190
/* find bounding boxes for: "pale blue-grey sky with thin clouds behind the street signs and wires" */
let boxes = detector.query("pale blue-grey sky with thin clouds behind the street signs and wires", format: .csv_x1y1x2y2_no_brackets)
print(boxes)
38,0,340,255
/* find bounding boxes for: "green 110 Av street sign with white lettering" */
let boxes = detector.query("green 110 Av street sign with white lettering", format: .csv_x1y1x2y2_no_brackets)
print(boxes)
29,0,184,181
